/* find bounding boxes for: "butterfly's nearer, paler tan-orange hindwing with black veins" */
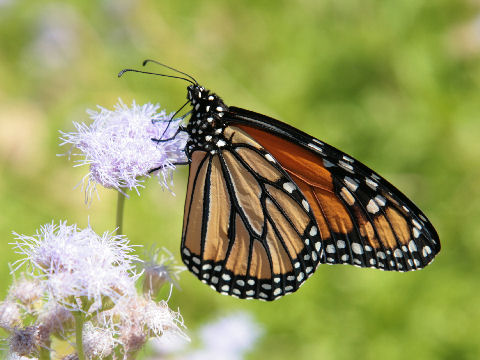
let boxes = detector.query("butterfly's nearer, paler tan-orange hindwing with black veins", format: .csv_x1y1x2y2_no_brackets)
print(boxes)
182,126,321,300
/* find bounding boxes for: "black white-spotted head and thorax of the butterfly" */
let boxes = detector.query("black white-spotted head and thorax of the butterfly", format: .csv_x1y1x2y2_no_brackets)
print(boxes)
186,85,229,158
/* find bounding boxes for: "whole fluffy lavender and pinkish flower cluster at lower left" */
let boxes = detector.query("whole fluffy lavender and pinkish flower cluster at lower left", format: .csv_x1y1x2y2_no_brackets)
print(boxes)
5,222,188,360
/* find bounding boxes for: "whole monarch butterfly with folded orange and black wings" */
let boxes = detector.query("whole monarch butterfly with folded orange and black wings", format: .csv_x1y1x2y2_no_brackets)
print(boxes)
119,60,440,300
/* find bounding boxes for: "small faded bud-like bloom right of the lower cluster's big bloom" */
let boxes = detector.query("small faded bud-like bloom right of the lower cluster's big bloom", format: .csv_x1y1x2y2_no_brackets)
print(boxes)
140,248,185,296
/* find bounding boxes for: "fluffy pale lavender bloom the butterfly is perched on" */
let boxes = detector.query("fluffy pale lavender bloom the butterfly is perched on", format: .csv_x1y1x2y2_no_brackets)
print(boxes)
61,100,187,201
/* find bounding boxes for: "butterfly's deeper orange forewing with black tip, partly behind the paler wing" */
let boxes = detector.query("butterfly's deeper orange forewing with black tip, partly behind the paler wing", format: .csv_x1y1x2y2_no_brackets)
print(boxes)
236,122,440,271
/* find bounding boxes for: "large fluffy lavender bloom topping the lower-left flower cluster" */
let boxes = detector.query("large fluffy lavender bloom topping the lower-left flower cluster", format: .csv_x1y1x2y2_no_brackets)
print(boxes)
14,222,138,310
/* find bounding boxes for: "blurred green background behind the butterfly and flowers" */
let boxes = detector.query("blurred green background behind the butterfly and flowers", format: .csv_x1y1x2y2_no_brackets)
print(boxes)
0,0,480,360
